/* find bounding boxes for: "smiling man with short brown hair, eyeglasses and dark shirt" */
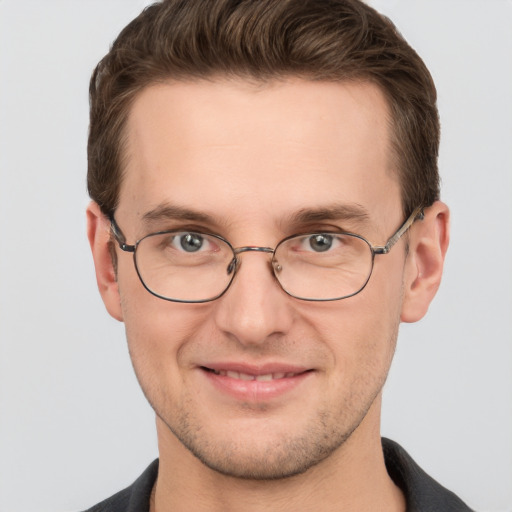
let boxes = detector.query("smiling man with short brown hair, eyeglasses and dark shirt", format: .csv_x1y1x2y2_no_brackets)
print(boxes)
87,0,469,512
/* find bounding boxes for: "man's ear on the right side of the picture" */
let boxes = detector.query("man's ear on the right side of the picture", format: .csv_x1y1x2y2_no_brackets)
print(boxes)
401,201,450,322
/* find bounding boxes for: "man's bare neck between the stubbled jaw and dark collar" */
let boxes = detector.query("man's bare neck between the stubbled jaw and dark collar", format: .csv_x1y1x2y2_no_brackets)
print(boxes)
151,404,405,512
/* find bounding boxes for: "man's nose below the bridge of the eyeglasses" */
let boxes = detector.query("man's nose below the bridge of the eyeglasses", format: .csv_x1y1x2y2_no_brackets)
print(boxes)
215,248,294,346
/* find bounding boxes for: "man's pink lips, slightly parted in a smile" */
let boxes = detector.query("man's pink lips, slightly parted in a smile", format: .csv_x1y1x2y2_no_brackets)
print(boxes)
199,362,314,402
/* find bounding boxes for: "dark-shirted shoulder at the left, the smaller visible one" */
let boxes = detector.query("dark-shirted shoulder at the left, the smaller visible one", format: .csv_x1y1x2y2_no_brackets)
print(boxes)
81,459,158,512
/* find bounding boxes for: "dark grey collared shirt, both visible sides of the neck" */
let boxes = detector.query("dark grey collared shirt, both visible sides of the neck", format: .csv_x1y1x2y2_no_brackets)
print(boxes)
86,439,473,512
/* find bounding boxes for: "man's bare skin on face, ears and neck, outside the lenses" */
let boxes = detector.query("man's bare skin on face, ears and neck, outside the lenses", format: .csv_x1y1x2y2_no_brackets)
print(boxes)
88,79,448,512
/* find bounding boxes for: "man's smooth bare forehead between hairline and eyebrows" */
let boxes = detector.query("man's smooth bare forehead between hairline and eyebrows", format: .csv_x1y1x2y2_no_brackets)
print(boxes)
119,80,400,236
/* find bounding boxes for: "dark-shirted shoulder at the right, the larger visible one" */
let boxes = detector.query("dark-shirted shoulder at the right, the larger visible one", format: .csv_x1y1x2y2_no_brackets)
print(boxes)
382,438,472,512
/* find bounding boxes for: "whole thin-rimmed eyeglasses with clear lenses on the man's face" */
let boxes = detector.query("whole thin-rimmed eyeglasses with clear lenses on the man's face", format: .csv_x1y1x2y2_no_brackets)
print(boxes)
110,208,423,303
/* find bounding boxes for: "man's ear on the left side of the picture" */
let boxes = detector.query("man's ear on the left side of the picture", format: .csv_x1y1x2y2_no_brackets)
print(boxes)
87,201,123,321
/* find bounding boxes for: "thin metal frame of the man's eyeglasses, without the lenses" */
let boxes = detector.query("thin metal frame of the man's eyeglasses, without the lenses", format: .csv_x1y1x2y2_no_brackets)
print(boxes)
110,206,425,304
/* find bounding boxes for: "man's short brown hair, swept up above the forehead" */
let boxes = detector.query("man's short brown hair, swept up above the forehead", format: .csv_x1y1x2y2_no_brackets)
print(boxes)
87,0,439,215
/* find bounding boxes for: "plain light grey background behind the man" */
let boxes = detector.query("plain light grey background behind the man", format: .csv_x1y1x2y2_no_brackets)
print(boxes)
0,0,512,512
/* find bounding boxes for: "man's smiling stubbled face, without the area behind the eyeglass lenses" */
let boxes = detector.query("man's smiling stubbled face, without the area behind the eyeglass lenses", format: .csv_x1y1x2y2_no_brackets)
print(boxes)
94,80,412,478
